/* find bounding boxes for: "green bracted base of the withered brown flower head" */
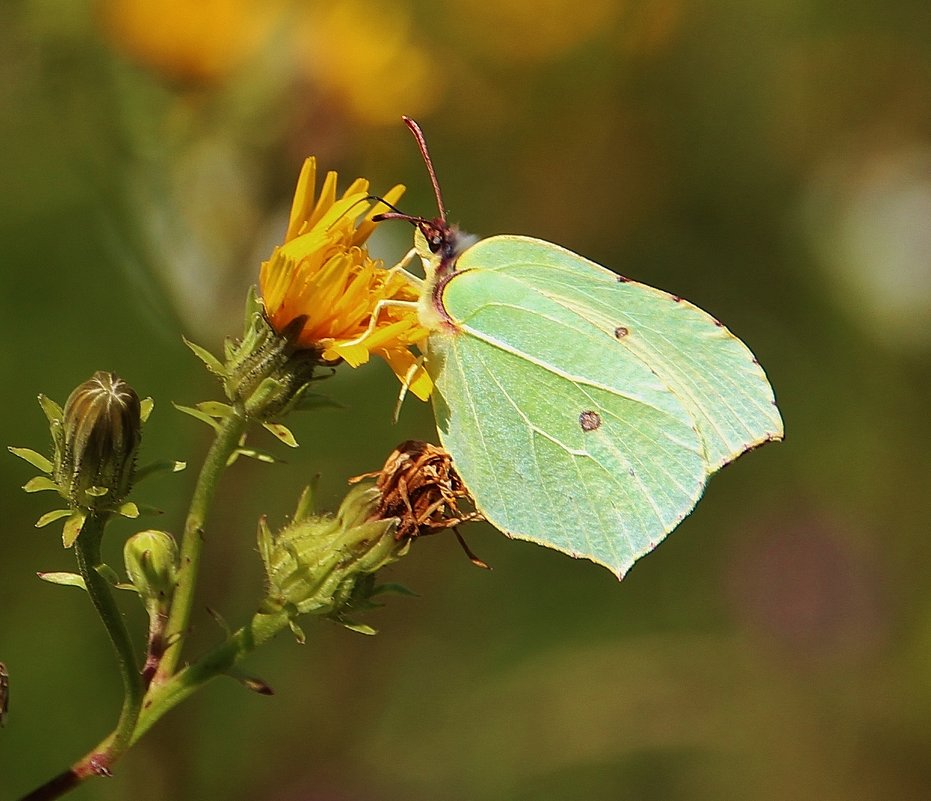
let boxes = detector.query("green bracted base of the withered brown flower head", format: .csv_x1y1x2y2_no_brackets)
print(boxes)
259,486,410,619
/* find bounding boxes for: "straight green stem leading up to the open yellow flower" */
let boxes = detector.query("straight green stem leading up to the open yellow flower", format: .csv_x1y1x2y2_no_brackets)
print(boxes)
152,406,247,687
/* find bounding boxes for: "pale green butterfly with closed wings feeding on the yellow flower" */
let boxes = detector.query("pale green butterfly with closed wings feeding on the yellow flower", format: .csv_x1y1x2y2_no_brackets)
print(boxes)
374,117,783,578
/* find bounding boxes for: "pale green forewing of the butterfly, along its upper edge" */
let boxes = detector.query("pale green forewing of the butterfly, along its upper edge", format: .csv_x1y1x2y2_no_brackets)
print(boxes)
459,236,782,473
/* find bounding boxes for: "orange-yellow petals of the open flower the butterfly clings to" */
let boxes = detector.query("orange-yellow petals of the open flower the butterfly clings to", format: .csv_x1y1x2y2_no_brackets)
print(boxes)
259,158,433,400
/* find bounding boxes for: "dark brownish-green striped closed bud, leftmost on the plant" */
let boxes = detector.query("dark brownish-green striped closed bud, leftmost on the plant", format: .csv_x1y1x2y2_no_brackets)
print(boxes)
53,370,142,509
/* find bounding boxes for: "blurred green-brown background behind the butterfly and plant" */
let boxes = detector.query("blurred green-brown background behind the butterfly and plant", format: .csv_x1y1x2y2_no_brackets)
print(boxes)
0,0,931,801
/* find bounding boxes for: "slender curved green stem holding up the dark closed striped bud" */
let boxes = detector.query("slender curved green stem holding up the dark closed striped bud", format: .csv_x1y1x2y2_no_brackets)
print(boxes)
74,513,144,773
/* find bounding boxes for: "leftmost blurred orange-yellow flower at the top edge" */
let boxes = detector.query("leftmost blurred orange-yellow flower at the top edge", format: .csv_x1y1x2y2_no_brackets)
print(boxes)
99,0,283,82
